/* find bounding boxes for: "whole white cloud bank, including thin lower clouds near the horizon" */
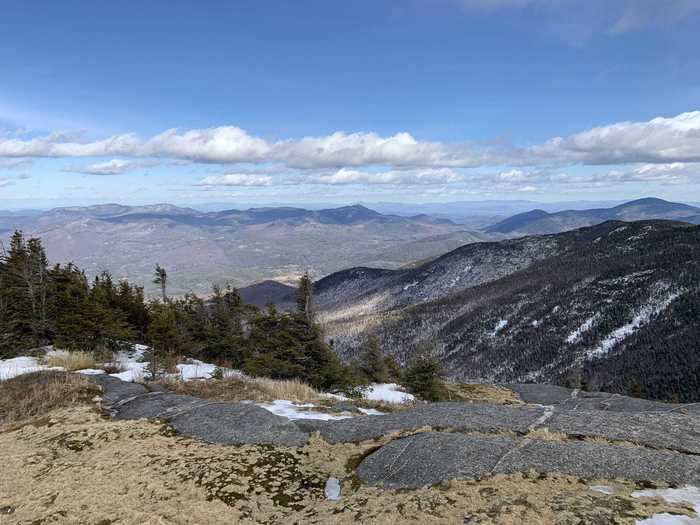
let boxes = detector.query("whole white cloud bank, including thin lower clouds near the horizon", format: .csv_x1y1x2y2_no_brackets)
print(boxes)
0,111,700,191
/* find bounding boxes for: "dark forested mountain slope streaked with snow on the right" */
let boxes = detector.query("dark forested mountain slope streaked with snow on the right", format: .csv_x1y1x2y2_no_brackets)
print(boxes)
298,217,700,401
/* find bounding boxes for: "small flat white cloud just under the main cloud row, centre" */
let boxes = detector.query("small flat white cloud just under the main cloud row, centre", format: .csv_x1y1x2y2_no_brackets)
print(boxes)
302,168,463,185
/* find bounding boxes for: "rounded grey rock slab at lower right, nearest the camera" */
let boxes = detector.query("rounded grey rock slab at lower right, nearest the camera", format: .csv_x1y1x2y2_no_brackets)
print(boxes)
357,432,700,489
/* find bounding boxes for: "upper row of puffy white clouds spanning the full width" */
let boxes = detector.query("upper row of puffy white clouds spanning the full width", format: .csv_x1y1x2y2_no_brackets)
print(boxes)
0,111,700,172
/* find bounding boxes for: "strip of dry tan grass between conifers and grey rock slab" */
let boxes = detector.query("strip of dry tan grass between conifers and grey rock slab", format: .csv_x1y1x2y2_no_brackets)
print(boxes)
168,377,324,403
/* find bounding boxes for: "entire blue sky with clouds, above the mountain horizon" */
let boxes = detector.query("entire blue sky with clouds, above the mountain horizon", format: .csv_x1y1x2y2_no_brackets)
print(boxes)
0,0,700,209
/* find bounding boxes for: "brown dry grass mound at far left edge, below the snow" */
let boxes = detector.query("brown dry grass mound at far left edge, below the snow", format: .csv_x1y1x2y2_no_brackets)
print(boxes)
0,371,99,430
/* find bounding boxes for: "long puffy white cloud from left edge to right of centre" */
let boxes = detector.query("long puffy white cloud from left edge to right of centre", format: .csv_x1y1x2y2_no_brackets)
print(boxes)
0,126,482,169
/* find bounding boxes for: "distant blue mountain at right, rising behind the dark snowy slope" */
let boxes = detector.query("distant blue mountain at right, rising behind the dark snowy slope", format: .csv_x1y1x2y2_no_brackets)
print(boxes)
484,198,700,235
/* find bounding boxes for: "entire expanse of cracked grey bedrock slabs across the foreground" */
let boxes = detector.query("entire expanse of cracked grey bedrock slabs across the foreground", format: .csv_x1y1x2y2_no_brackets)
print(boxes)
94,376,700,490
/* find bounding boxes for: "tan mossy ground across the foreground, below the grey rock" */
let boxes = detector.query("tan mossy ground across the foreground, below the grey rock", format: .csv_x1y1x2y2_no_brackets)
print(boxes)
0,405,684,525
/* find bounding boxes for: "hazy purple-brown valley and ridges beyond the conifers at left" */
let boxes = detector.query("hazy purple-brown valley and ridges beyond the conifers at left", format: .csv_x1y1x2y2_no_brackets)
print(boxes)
0,204,489,294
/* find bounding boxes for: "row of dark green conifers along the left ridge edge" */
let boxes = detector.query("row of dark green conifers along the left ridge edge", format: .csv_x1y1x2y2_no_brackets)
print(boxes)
0,232,440,398
